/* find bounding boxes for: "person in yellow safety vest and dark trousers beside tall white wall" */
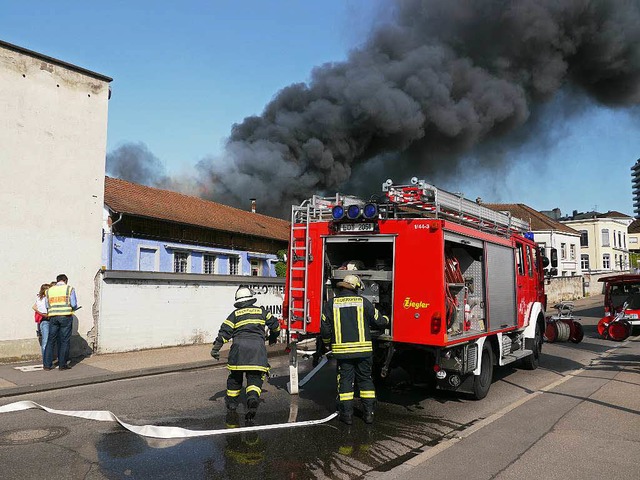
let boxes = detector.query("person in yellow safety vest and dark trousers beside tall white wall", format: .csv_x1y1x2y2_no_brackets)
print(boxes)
43,273,78,370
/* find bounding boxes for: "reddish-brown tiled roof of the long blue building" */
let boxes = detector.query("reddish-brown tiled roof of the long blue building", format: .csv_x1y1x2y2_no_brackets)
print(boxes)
104,177,289,242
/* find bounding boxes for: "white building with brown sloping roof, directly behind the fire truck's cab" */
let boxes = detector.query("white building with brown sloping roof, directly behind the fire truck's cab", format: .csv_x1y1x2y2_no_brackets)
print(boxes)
483,203,582,277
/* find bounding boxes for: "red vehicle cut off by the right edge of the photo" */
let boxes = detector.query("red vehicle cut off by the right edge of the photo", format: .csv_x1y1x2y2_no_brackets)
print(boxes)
598,274,640,342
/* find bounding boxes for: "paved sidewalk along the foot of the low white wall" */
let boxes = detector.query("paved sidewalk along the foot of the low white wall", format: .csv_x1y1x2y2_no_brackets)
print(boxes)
0,344,285,398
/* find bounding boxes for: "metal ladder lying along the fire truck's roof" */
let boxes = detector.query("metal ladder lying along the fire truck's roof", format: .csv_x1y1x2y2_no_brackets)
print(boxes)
382,177,529,236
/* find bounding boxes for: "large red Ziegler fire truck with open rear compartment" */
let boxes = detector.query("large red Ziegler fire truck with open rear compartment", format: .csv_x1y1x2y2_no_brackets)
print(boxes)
283,178,546,399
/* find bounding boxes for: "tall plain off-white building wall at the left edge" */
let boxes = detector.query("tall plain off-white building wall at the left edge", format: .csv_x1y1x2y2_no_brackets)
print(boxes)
0,42,110,361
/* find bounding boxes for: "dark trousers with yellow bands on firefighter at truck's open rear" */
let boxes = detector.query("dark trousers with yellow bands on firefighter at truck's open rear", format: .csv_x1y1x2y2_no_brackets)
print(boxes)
337,355,376,415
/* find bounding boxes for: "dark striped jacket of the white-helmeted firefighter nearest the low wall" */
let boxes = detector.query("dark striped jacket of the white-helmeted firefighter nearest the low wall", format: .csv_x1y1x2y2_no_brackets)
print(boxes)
216,300,280,373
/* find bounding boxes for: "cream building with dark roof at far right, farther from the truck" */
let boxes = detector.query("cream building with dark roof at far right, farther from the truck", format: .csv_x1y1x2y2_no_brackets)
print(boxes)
560,210,633,273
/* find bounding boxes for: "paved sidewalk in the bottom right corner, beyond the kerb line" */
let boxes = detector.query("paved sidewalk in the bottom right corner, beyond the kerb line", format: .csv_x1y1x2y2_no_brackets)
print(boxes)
380,336,640,480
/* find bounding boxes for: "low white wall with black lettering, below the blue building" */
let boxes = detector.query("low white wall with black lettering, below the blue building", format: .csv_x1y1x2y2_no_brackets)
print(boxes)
95,271,284,353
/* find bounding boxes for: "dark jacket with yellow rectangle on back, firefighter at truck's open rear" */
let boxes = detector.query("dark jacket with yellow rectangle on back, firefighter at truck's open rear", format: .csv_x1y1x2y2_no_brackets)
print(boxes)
320,289,389,359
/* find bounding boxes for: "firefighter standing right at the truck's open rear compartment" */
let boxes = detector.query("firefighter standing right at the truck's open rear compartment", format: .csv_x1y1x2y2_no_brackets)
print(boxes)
320,275,389,425
